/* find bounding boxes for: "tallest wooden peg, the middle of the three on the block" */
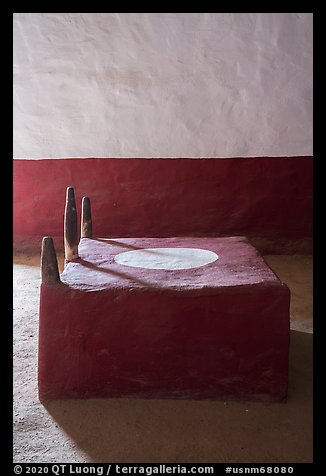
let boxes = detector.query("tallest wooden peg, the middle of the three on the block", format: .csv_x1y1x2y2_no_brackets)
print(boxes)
64,187,78,261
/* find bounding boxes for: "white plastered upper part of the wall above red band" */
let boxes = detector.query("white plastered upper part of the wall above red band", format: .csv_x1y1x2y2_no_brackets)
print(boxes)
13,13,312,158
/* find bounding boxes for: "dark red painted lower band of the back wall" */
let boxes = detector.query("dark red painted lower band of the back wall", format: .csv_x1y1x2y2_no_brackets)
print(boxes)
14,157,312,253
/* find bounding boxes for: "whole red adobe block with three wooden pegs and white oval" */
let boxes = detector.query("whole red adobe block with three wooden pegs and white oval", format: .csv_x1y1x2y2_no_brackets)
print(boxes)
38,187,290,402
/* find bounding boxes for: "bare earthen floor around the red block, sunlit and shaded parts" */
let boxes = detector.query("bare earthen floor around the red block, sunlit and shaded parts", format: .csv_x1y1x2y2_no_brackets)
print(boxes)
14,254,313,463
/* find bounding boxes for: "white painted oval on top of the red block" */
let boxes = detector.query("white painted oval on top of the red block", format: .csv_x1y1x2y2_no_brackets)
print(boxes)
114,248,218,270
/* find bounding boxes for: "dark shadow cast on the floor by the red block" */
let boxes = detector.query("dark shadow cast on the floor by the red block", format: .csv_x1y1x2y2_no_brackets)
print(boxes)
44,331,312,463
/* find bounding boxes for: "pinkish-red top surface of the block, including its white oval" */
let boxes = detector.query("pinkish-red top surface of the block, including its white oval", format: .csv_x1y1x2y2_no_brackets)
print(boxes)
61,236,281,292
